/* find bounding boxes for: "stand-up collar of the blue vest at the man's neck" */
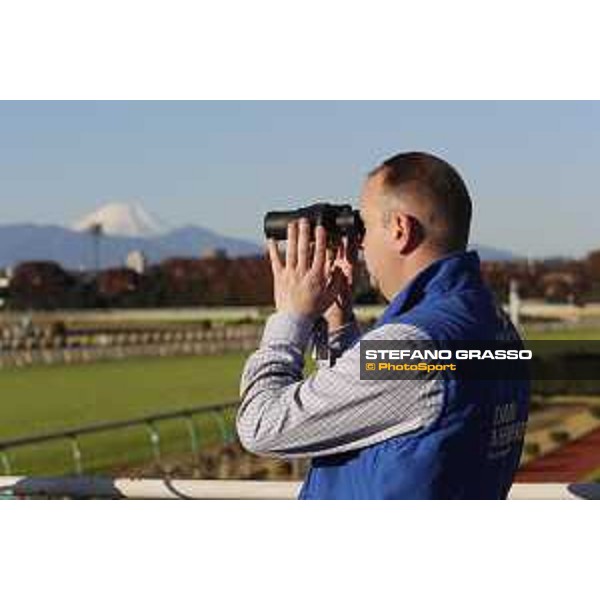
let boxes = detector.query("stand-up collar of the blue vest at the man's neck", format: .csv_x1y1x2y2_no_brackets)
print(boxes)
379,250,481,323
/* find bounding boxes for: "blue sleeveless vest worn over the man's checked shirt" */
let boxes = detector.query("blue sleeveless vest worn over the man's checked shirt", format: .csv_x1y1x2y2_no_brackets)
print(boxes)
300,252,529,499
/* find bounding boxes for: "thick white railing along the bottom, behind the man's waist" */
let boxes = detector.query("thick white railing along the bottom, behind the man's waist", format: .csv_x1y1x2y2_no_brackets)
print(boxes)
0,477,600,500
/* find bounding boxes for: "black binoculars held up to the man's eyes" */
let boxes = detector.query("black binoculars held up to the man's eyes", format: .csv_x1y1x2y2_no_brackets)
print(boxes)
264,203,365,242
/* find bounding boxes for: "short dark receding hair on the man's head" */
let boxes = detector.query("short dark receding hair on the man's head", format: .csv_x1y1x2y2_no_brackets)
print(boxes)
369,152,472,251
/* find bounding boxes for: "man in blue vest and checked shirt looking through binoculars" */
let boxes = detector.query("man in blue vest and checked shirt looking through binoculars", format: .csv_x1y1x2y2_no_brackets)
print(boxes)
237,152,529,498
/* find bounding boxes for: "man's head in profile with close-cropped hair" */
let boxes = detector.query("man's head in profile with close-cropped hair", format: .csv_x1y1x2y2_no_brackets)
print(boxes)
360,152,471,300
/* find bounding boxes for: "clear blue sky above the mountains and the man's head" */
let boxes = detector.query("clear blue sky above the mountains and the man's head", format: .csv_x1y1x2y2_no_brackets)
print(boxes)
0,101,600,256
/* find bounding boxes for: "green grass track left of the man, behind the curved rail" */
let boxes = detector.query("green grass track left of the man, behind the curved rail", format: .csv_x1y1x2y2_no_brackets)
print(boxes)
0,354,245,474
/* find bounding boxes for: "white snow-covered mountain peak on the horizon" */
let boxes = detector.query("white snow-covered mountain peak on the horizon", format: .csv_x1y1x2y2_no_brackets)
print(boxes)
72,202,166,238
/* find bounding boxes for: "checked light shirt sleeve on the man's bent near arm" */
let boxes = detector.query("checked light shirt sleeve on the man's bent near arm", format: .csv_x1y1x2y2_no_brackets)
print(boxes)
237,313,443,458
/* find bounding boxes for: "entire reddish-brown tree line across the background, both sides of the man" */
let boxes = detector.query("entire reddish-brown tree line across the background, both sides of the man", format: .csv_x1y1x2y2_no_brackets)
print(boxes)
6,250,600,310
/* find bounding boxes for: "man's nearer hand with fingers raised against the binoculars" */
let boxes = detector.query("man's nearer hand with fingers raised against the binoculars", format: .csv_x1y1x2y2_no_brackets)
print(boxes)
268,219,343,317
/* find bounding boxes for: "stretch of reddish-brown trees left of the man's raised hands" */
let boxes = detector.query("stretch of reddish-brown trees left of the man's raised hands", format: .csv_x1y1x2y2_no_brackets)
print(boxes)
7,257,273,310
